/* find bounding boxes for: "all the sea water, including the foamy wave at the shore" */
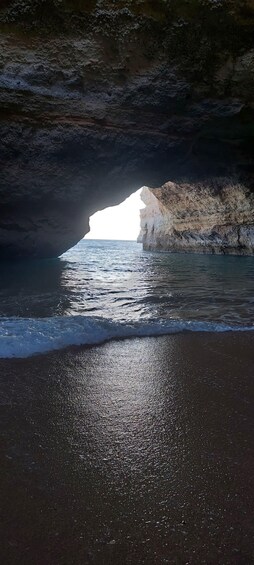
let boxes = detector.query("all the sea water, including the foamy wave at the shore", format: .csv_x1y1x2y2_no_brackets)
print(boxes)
0,240,254,357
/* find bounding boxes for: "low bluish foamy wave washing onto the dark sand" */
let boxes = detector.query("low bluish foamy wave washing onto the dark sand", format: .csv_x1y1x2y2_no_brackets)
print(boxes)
0,316,254,358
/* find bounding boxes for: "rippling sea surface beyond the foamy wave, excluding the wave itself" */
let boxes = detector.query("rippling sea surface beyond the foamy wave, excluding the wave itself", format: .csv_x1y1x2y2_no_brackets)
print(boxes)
0,240,254,325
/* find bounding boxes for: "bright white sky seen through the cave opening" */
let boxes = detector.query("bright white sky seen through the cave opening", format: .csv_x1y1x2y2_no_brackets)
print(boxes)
85,188,145,240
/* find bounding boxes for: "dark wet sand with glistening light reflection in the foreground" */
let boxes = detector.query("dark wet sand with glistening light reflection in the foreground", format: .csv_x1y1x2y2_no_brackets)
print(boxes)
0,333,254,565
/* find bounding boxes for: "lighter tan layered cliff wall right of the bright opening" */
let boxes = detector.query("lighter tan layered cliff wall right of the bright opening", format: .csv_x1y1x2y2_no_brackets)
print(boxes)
139,182,254,255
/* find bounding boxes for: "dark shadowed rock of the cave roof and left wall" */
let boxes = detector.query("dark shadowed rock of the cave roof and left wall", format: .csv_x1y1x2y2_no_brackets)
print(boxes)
0,0,254,258
